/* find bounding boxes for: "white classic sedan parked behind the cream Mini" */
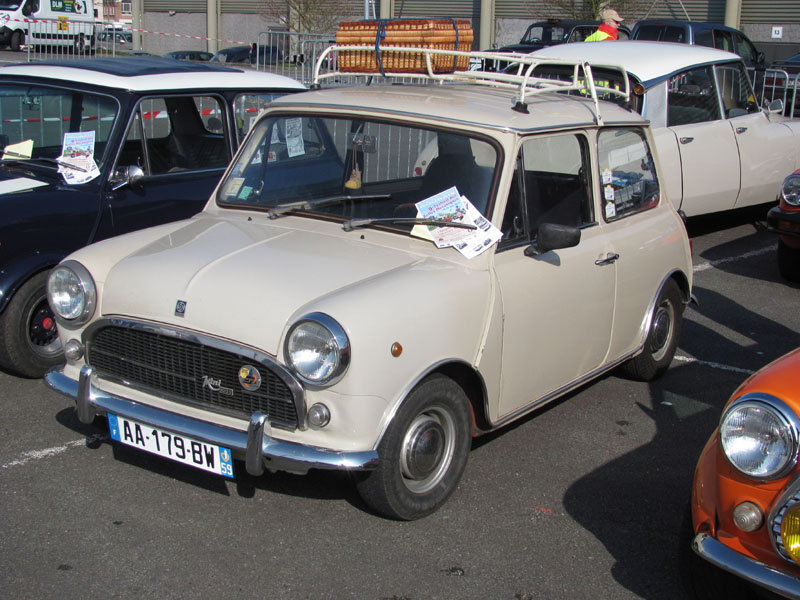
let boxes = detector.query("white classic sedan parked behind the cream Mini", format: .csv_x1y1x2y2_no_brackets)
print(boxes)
532,41,800,217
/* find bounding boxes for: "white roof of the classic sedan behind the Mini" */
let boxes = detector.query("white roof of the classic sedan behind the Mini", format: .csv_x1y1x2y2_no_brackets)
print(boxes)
531,40,742,87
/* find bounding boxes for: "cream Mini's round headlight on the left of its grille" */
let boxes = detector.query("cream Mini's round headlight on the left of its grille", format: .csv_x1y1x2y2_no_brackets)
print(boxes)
47,260,97,327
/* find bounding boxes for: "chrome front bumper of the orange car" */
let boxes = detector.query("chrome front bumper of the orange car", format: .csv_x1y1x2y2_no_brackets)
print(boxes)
692,533,800,598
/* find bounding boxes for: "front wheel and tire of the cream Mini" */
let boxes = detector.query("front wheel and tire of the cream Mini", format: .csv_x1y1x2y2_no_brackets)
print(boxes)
357,375,472,521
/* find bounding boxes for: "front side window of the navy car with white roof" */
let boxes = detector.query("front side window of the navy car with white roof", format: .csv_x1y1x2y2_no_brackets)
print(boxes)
118,96,230,175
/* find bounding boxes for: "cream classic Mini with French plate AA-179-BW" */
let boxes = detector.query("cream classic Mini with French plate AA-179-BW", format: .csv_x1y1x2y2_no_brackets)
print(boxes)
46,44,692,519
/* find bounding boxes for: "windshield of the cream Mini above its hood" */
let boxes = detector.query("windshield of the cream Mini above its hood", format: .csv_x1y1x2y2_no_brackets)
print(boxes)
217,115,497,227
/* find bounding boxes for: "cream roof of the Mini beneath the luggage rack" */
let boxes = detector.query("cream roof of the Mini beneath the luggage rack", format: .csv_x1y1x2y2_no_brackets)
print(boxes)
271,83,644,132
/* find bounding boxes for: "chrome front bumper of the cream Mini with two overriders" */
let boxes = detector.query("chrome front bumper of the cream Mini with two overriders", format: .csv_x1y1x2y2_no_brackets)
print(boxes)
44,366,378,476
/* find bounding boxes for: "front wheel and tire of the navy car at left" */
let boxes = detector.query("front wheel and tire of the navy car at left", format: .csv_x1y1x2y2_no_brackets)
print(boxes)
0,271,64,378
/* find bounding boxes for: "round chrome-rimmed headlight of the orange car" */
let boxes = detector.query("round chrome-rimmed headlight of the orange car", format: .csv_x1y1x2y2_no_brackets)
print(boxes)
719,394,798,479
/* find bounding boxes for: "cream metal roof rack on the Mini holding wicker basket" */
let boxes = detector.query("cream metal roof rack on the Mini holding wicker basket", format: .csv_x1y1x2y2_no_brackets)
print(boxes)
311,45,631,124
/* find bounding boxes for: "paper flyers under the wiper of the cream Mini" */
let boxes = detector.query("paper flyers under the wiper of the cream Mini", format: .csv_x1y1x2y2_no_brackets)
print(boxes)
411,186,503,258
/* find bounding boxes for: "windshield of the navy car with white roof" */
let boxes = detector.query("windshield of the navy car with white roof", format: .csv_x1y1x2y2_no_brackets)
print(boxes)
0,83,119,164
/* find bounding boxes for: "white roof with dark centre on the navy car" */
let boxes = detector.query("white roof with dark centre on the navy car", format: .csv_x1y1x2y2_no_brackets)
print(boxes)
0,56,305,92
